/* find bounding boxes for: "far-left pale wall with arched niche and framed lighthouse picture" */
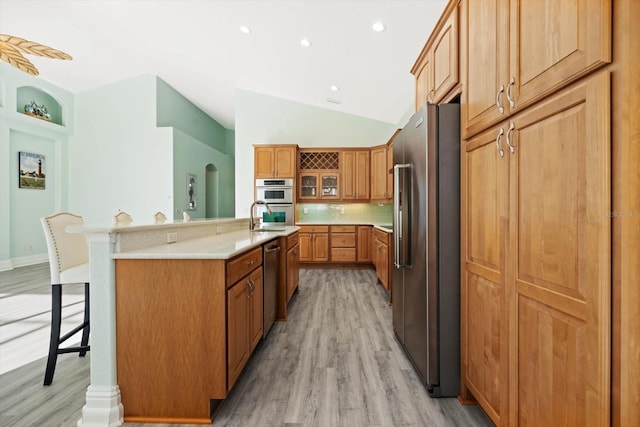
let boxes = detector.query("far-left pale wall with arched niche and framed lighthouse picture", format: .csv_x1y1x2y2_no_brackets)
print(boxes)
0,62,75,271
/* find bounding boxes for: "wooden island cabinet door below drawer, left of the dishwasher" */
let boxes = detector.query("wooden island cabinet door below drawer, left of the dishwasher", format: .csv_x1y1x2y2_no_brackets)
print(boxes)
227,267,263,390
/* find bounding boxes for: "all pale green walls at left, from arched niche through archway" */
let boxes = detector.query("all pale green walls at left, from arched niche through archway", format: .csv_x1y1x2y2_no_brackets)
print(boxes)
0,67,235,271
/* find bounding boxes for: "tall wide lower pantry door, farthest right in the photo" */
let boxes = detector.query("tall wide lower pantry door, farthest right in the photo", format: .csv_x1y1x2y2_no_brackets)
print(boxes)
505,72,611,426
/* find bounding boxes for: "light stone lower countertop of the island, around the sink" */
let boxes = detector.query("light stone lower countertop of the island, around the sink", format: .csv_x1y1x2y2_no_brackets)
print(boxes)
113,226,300,259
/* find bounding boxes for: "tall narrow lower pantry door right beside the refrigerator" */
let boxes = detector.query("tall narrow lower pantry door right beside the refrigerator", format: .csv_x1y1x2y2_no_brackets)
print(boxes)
461,121,509,425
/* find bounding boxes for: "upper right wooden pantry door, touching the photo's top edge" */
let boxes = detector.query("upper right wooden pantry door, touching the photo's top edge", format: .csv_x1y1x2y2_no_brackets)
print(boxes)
510,0,612,111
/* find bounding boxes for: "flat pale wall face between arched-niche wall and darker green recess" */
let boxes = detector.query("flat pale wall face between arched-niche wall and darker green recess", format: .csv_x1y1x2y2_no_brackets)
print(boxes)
68,75,173,225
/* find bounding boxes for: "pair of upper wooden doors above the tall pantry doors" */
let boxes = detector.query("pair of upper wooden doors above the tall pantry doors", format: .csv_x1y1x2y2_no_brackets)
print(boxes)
461,0,611,137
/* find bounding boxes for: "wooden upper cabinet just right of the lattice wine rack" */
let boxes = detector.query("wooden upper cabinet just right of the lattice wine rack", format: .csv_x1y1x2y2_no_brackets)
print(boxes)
340,149,371,201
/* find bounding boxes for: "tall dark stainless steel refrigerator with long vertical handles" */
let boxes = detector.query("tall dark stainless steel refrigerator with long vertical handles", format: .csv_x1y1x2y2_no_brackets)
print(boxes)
392,104,460,397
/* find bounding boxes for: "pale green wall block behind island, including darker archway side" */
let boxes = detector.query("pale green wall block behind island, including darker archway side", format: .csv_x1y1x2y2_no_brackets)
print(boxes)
69,75,234,224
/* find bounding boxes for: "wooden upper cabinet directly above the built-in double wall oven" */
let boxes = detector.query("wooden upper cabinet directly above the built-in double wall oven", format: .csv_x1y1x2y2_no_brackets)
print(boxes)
254,145,298,178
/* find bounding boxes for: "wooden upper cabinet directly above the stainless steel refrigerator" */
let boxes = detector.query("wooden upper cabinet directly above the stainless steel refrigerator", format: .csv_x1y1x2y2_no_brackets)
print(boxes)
411,1,459,111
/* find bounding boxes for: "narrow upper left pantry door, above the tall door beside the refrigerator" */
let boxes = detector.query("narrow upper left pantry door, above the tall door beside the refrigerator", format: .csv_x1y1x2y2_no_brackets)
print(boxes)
460,0,509,138
